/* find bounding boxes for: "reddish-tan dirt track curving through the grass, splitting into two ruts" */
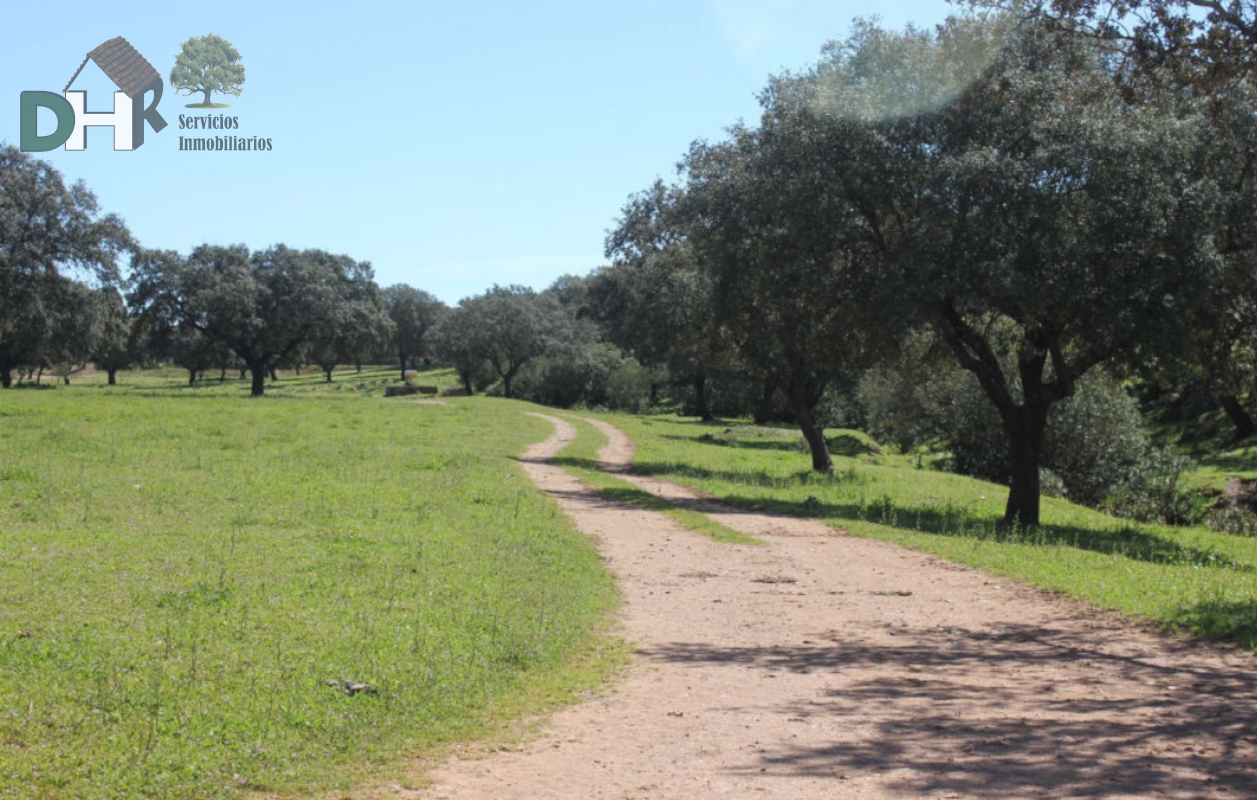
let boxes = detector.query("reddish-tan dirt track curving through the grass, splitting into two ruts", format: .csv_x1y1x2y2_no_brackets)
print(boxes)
389,415,1257,800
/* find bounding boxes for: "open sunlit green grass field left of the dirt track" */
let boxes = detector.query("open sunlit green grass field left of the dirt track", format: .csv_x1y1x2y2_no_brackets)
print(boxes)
0,371,622,799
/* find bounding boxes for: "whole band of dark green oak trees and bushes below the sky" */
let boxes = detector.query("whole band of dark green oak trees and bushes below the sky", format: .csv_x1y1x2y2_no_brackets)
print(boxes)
7,0,1257,525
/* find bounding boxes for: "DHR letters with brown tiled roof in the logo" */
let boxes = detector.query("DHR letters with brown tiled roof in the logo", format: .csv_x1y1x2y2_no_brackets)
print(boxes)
21,36,166,152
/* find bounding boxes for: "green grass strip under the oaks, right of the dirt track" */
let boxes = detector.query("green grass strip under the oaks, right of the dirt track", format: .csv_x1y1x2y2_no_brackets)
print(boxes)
600,415,1257,649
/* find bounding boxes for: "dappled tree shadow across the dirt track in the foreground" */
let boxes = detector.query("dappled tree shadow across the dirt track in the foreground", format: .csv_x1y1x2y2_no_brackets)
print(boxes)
640,624,1257,799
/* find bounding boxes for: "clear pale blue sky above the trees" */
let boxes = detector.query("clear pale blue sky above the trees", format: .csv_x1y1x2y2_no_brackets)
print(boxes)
0,0,952,303
